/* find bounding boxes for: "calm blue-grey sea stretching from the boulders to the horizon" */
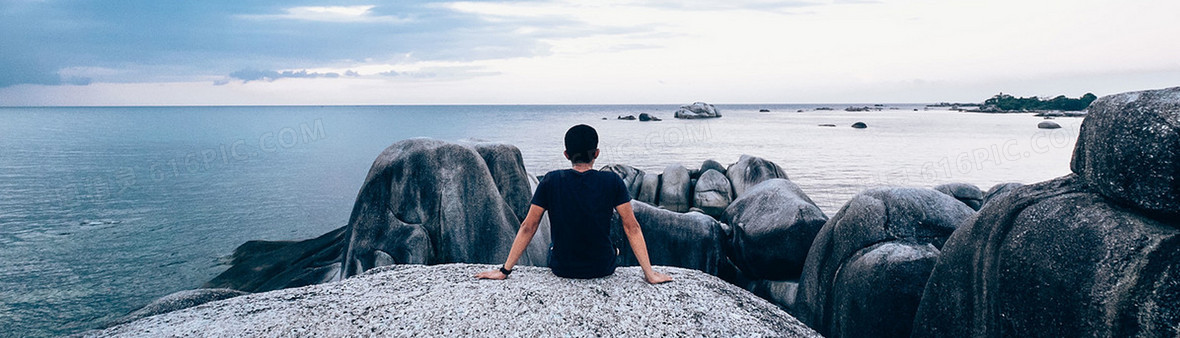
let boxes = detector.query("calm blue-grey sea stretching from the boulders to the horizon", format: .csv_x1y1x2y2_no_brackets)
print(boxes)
0,104,1081,336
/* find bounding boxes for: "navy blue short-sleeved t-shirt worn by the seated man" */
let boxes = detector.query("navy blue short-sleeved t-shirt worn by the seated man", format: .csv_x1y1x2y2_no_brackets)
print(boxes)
532,169,631,278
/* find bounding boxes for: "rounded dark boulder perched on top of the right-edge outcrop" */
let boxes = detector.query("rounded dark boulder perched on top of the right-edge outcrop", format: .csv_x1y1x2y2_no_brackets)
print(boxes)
1070,87,1180,216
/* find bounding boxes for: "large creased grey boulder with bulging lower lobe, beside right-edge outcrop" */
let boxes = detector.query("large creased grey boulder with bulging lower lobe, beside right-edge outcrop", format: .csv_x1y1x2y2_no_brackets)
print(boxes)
792,188,975,337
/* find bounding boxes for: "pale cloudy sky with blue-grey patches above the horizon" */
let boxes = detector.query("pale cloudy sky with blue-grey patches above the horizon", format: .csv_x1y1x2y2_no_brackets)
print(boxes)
0,0,1180,105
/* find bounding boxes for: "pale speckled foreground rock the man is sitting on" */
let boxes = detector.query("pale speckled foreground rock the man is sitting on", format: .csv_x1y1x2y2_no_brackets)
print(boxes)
83,264,819,337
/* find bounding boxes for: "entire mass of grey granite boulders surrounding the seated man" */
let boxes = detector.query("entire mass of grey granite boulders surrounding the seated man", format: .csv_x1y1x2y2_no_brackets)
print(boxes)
112,87,1180,337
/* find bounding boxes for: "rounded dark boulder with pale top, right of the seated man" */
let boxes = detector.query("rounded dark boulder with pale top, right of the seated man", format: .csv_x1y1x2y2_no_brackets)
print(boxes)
721,178,827,280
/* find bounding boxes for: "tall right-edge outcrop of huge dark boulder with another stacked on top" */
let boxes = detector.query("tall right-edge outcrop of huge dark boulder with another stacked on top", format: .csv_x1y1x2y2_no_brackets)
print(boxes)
913,87,1180,337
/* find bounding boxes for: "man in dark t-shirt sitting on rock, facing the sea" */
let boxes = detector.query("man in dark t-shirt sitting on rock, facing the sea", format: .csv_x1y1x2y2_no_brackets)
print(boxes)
476,124,671,284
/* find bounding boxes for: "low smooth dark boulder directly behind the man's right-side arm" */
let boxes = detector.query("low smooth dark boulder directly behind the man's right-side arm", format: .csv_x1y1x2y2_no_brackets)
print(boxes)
611,201,729,275
